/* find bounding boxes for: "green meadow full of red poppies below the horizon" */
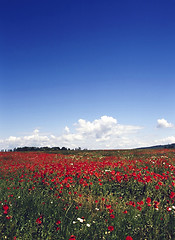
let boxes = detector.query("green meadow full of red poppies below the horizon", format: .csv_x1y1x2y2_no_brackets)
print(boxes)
0,149,175,240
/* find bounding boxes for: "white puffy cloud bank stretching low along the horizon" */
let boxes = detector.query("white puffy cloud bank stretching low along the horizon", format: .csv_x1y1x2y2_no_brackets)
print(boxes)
0,116,175,149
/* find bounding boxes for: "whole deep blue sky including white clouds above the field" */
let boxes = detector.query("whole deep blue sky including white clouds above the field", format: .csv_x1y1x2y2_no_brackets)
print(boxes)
0,0,175,149
